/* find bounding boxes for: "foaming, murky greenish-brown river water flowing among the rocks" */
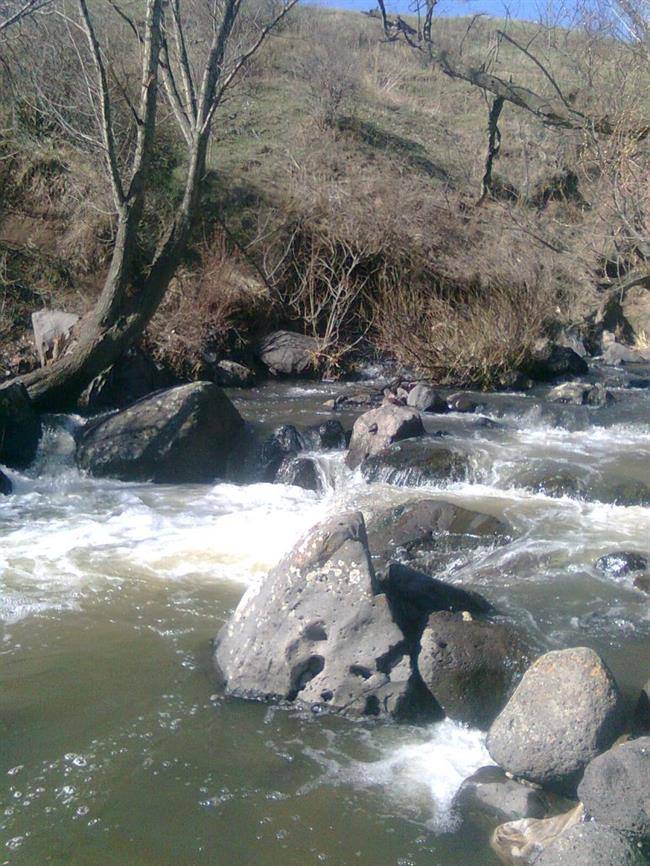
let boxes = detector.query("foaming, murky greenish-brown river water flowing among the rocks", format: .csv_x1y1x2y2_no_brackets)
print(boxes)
0,374,650,866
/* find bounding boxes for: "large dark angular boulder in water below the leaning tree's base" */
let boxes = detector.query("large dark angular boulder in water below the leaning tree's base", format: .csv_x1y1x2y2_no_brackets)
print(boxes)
77,382,244,483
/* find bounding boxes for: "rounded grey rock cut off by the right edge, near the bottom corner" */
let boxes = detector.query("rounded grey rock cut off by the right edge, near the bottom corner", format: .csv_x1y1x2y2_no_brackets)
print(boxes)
578,737,650,839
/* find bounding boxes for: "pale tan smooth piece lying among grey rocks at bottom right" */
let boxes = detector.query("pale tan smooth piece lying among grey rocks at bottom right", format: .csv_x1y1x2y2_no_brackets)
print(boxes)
490,803,584,866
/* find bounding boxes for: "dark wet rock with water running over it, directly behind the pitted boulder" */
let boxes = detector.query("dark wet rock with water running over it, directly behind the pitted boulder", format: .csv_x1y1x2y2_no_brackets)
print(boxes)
368,499,512,576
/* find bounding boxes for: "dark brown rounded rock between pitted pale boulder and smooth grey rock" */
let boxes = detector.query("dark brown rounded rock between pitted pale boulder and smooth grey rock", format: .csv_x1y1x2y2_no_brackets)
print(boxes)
418,611,530,729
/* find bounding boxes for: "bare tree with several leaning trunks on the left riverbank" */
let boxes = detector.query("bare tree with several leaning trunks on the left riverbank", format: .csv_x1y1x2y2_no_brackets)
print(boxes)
14,0,297,408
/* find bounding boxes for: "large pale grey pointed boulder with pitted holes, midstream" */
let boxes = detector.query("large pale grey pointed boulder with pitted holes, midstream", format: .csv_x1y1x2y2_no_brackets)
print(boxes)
215,513,439,718
